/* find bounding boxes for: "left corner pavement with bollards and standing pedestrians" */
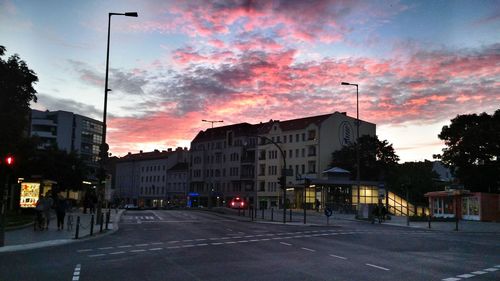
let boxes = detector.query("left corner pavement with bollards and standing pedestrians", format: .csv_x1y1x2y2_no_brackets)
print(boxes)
0,209,123,253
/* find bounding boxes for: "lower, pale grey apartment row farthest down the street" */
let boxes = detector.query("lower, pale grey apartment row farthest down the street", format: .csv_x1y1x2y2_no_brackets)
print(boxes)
114,147,189,207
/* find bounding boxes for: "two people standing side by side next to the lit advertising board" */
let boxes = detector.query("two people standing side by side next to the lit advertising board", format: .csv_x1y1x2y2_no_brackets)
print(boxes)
35,192,69,230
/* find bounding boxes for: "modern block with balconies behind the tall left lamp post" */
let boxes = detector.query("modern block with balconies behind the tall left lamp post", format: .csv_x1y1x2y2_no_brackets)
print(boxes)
30,109,102,180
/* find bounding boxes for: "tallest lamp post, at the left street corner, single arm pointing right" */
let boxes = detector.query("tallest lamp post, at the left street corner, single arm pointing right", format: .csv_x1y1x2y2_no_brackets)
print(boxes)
96,12,138,224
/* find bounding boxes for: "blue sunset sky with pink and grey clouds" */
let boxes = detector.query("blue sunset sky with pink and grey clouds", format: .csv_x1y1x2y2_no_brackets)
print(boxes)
0,0,500,162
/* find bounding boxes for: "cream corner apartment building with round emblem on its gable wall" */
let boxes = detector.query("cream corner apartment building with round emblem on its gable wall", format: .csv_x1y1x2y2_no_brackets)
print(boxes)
256,112,376,208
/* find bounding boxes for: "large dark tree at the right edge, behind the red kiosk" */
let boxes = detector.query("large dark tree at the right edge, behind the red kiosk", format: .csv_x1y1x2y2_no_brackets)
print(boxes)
434,109,500,192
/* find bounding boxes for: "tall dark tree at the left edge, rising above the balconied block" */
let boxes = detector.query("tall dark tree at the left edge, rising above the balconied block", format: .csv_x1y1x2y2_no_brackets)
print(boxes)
0,46,38,155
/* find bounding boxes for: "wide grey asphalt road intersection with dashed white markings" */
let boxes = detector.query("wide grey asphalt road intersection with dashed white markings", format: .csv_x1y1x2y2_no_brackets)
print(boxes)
0,210,500,281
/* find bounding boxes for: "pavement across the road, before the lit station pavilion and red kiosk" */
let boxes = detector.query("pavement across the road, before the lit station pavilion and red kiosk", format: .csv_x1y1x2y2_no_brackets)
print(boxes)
210,208,500,232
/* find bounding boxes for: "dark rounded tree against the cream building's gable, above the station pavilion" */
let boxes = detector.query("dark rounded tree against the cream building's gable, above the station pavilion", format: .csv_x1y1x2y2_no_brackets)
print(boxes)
331,135,399,180
